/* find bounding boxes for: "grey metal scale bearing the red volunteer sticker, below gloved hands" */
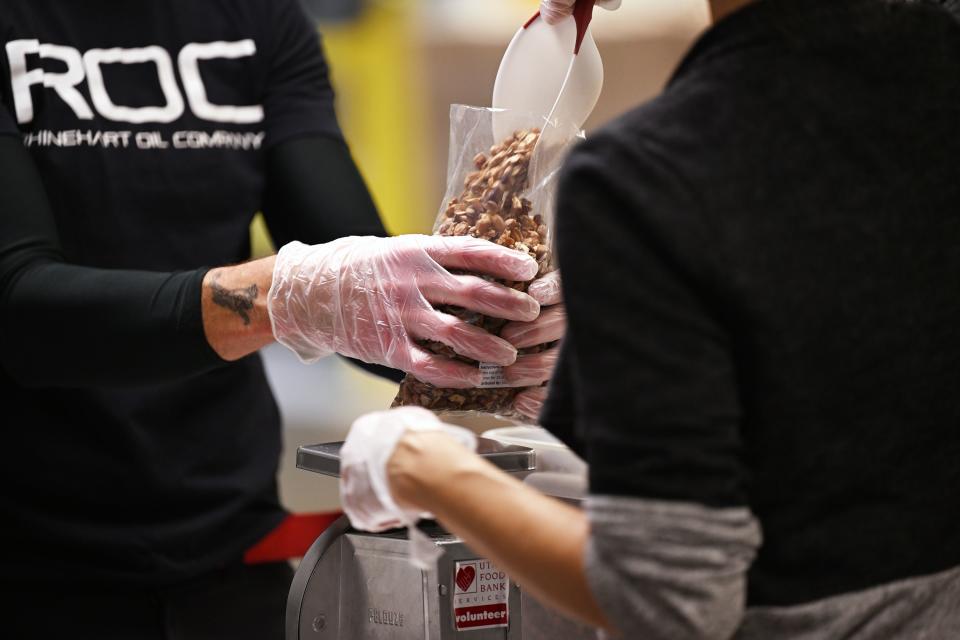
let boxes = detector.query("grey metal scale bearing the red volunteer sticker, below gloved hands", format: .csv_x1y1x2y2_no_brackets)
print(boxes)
286,438,596,640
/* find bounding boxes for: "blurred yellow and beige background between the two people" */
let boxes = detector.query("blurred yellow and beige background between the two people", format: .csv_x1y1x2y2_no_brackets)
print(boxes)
252,0,709,513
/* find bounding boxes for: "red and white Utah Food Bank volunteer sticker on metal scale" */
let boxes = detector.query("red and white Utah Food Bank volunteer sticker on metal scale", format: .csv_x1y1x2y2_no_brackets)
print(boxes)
453,560,510,631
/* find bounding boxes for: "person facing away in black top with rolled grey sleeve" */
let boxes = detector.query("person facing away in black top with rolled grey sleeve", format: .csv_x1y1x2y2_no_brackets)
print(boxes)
341,0,960,640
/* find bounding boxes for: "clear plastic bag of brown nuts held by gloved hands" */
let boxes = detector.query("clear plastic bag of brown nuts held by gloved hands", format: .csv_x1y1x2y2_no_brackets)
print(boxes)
393,105,583,418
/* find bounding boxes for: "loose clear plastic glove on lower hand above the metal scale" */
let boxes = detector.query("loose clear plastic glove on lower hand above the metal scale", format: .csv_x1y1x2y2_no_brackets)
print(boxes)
340,407,477,567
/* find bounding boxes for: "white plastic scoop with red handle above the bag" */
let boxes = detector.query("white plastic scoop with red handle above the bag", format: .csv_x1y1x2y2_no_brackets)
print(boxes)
493,0,603,140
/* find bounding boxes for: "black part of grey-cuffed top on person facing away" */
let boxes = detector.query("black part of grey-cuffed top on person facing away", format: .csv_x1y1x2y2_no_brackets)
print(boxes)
544,0,960,612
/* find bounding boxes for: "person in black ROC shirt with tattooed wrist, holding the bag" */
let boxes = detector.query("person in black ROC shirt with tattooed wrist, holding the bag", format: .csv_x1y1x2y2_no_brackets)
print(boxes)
0,0,538,638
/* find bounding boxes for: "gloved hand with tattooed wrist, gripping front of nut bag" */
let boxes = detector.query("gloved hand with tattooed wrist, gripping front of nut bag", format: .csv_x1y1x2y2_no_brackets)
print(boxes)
268,235,540,388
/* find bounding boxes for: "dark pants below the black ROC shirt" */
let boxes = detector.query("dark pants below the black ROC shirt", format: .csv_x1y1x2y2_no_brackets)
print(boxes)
0,563,293,640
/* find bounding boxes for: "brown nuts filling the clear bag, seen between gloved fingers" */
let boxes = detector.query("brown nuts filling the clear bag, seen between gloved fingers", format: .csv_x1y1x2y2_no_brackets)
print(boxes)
393,129,552,413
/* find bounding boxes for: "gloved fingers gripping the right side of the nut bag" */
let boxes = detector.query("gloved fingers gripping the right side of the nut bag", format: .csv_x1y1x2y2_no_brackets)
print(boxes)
500,271,567,420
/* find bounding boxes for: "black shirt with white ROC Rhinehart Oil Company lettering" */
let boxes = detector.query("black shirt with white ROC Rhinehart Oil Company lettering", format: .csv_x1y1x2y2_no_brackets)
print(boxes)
0,0,383,585
